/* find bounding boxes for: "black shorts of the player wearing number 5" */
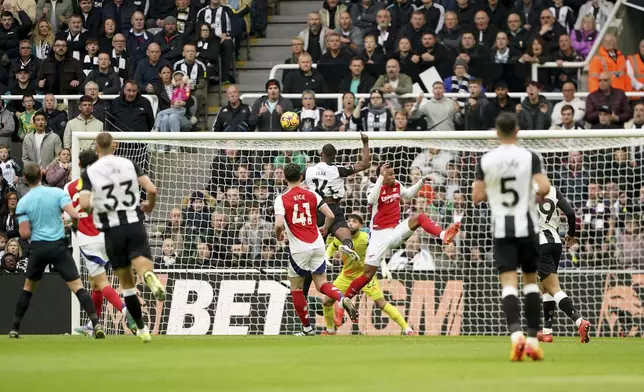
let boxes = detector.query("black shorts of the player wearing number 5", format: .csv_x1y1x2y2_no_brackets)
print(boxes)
494,235,539,273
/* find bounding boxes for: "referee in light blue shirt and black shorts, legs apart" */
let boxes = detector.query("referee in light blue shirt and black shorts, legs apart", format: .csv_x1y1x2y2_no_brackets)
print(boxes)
9,162,105,339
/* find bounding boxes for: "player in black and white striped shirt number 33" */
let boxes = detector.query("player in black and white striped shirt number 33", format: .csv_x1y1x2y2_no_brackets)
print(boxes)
79,132,165,343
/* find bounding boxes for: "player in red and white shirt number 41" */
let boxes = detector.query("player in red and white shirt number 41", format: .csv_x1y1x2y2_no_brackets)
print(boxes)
275,163,358,335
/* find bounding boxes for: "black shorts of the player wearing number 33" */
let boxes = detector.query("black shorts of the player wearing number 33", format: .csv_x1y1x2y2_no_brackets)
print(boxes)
105,222,152,269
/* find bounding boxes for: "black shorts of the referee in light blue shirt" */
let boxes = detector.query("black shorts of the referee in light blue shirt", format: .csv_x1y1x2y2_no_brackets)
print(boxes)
26,239,80,282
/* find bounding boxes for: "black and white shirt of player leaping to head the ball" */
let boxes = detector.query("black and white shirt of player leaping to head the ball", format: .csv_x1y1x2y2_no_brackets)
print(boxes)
304,162,356,200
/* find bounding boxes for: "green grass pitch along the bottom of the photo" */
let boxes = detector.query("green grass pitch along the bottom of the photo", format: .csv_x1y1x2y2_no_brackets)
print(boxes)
0,336,644,392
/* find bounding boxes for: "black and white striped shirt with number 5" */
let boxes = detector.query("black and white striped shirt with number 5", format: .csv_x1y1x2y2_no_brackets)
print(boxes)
476,144,541,238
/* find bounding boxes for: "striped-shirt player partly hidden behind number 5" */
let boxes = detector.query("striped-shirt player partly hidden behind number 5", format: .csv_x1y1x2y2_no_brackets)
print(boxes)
537,186,591,343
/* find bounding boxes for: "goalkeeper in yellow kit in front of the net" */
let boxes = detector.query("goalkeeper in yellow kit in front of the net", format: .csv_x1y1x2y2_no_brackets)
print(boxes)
322,214,416,335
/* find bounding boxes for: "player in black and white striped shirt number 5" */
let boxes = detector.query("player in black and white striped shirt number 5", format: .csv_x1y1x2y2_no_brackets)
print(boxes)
472,113,550,361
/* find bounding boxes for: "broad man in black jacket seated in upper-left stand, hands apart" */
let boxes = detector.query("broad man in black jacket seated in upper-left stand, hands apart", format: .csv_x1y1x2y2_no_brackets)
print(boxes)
38,39,85,95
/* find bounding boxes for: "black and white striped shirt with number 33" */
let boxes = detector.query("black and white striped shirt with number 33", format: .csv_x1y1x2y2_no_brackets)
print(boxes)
81,155,145,231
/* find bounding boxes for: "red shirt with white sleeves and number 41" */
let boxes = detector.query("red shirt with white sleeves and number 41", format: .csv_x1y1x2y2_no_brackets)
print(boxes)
275,187,324,253
